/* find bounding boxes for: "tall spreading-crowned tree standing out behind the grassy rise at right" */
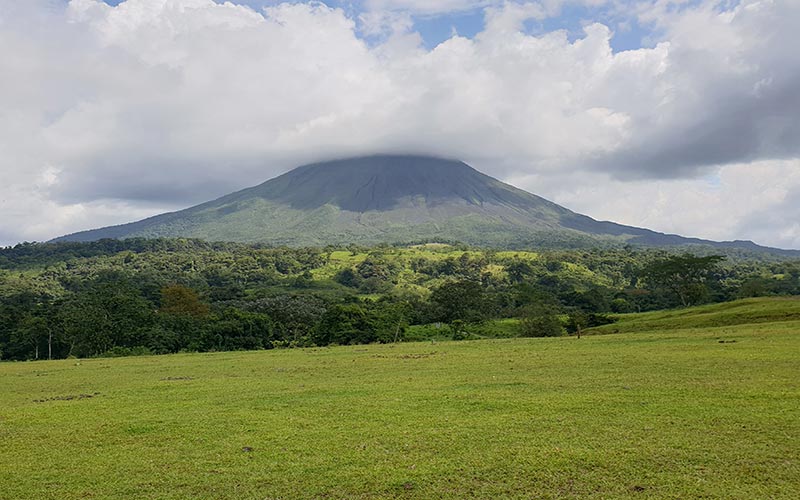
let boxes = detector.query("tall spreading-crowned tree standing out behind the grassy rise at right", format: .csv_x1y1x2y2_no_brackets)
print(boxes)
643,253,725,307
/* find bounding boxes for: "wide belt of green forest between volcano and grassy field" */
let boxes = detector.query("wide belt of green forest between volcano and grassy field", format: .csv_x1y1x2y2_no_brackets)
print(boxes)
0,239,800,360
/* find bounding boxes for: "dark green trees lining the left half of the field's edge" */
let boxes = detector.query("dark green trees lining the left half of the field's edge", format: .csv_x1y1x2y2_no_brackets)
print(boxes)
0,271,406,359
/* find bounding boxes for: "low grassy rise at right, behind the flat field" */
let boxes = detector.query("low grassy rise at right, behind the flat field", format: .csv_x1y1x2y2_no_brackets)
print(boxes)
587,297,800,334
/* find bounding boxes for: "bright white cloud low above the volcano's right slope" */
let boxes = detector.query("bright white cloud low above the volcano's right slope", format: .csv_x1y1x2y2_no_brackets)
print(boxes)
510,159,800,248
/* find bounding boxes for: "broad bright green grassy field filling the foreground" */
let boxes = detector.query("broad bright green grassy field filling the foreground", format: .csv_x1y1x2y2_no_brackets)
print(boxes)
0,301,800,500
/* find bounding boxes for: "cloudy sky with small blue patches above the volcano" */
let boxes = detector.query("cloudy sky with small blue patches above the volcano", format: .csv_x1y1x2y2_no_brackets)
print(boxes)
0,0,800,249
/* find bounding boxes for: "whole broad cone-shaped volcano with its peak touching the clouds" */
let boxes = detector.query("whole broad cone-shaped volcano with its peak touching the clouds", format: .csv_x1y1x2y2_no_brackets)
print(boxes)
57,155,788,250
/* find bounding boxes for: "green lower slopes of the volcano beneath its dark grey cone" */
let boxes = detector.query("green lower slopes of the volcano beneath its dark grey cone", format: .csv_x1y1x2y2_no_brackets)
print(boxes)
59,198,628,248
